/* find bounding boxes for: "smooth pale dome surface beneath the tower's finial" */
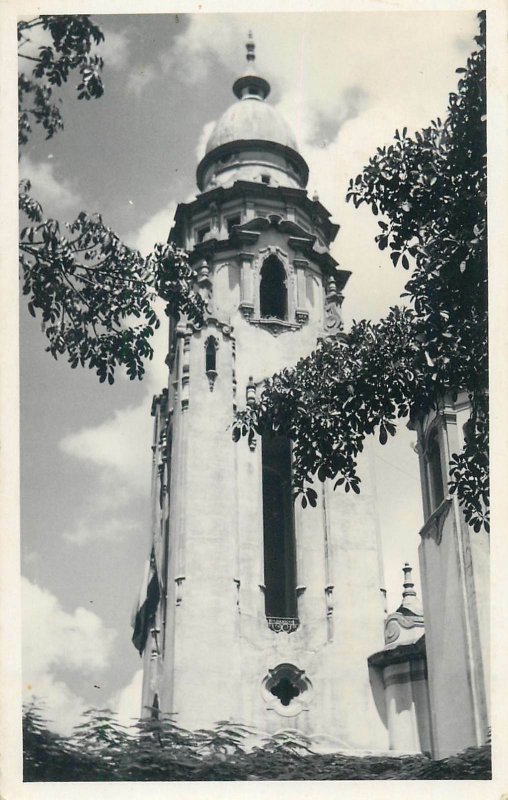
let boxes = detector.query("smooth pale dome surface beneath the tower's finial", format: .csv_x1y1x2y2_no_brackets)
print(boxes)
206,94,298,153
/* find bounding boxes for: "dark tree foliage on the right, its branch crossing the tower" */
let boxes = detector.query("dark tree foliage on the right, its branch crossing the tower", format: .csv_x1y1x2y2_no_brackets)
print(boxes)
233,14,488,530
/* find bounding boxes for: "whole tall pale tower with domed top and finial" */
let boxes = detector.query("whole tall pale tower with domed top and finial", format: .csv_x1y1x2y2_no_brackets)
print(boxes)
134,37,389,750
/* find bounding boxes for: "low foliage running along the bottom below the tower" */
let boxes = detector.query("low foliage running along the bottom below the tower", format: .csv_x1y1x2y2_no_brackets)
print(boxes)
23,705,491,781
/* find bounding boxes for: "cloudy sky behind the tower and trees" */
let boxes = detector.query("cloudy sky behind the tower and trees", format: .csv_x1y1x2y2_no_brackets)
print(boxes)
16,11,477,733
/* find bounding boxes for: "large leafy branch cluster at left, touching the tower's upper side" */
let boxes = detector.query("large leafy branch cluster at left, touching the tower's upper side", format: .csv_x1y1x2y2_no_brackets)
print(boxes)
19,189,202,383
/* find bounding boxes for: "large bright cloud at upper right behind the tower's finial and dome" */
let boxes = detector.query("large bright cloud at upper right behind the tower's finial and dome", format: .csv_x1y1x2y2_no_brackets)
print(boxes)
140,11,477,322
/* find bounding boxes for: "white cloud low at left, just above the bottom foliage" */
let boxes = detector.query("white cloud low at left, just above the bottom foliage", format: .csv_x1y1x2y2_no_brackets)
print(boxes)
21,578,116,735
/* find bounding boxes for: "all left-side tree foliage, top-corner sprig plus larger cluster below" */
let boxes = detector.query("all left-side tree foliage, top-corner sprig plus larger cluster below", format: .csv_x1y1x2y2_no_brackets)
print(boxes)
18,15,204,383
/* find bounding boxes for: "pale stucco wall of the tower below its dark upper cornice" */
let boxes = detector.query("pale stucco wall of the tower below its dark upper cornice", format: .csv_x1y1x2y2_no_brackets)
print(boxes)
141,192,388,751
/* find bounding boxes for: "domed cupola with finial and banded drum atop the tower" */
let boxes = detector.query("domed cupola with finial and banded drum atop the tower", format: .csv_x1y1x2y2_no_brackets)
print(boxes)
197,33,309,191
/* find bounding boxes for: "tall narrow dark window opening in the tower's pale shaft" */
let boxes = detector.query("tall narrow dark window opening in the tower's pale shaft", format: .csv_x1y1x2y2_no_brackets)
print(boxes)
261,435,297,618
